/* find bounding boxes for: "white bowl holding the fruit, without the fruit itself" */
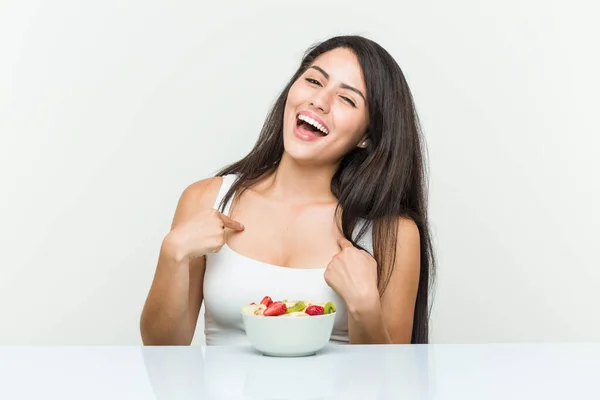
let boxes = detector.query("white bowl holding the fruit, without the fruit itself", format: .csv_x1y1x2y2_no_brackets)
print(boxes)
242,313,336,357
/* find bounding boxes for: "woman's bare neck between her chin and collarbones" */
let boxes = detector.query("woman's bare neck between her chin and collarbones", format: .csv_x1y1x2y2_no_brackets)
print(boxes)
261,152,338,204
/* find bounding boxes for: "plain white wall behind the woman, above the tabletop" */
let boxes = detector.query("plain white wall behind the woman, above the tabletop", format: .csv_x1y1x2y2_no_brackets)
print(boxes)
0,0,600,345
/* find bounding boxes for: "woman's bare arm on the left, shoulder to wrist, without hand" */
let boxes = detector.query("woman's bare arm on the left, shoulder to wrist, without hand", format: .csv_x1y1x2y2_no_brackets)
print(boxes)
140,178,221,345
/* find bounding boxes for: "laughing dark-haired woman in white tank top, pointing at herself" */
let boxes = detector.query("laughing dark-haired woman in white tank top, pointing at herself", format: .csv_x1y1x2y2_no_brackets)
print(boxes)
141,36,434,345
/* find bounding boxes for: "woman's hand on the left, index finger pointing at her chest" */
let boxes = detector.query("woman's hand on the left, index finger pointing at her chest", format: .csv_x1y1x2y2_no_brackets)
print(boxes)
165,209,244,261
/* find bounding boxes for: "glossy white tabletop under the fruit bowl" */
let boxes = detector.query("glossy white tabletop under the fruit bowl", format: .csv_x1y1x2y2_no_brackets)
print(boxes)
0,344,600,400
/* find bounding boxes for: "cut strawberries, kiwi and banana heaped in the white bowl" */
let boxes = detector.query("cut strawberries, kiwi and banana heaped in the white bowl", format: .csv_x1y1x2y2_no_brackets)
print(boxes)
242,296,335,317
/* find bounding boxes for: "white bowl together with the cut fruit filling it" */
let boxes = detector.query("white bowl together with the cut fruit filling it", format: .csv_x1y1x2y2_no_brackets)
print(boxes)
242,296,336,357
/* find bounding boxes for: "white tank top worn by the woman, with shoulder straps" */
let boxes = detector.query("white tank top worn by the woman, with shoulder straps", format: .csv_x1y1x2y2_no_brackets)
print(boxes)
204,175,373,345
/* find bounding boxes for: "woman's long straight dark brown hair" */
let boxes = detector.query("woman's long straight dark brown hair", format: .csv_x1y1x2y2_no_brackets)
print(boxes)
217,36,435,343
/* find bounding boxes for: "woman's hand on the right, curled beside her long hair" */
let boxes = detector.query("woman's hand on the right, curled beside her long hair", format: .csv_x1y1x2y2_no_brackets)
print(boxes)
325,236,379,309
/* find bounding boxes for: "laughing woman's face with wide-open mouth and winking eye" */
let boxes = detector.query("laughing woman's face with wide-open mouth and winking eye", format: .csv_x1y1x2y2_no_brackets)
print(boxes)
283,48,368,164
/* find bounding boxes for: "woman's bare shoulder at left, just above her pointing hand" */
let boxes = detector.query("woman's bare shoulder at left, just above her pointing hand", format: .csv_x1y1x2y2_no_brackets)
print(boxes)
173,176,223,226
